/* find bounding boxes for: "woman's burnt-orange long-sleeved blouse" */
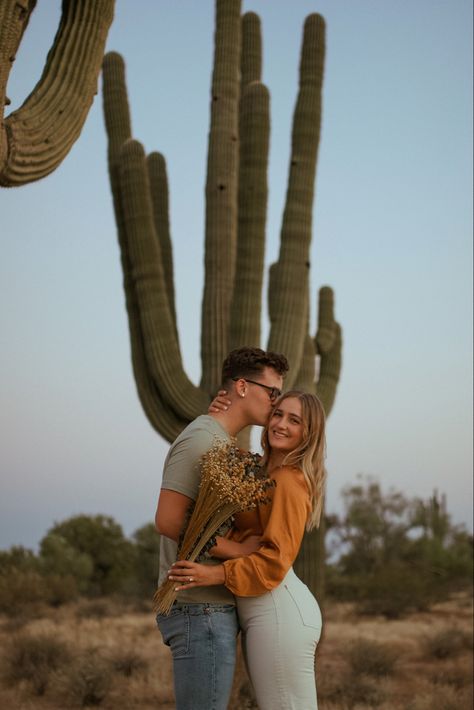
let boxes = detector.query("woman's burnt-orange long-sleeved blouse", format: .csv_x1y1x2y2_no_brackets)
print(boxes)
223,466,311,597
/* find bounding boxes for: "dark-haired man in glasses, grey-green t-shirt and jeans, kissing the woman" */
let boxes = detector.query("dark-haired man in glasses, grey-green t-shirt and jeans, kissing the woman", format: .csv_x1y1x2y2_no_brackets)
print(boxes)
155,347,288,710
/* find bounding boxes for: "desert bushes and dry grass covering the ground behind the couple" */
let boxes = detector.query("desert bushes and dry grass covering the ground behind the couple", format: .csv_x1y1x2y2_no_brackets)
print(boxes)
0,480,473,710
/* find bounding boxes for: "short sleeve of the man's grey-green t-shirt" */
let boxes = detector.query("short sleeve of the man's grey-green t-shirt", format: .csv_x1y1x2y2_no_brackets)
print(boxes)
161,428,215,500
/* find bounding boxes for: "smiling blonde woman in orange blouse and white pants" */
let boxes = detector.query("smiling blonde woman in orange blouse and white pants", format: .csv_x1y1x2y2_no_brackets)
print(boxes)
169,391,326,710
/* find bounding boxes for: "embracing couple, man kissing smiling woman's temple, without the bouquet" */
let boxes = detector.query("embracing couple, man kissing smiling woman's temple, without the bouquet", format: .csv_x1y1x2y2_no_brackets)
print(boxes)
156,347,325,710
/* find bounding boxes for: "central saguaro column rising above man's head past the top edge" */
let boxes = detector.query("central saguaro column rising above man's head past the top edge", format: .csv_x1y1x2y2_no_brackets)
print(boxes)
201,0,241,392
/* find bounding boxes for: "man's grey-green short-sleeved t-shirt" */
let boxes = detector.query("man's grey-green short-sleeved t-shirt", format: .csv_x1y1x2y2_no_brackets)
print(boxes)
158,414,234,604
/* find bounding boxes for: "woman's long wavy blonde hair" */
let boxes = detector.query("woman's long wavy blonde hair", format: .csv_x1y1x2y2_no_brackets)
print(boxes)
262,390,326,530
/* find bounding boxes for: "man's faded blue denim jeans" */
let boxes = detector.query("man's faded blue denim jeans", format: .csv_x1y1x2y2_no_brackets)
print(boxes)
156,604,239,710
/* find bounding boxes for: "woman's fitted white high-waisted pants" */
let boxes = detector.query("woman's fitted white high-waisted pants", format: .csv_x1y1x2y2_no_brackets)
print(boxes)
236,569,322,710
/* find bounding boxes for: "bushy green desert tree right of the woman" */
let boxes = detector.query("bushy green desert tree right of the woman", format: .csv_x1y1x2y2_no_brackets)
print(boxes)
328,479,473,617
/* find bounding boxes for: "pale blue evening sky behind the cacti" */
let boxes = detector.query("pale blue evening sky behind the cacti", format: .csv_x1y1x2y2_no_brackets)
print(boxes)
0,0,473,547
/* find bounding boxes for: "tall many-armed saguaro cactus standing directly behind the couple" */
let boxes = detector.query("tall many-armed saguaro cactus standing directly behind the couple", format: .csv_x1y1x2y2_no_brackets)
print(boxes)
104,0,341,591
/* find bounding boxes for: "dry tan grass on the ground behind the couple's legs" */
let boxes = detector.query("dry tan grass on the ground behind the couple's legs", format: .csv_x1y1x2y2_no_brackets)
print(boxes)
0,596,472,710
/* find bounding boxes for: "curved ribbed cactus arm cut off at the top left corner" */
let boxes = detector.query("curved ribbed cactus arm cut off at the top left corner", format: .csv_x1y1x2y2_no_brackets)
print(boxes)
0,0,114,187
